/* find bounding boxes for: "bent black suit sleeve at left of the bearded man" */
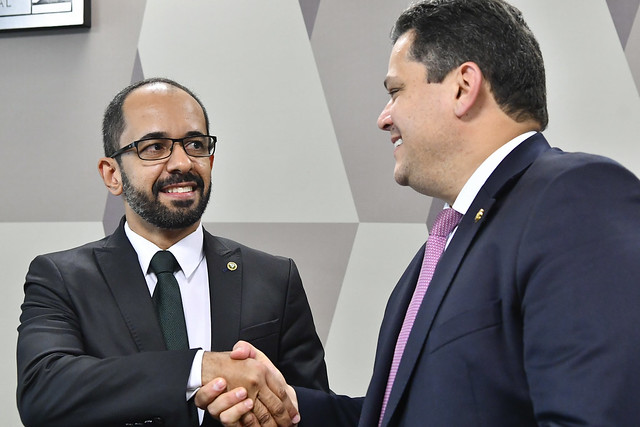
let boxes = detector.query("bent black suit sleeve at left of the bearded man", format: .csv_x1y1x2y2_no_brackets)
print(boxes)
17,256,195,427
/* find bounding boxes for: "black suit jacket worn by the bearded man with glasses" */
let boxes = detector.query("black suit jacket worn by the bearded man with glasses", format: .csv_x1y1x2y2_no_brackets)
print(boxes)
17,222,328,427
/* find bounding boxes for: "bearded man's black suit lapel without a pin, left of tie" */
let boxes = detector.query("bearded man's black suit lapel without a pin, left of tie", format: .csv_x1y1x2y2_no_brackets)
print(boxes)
94,220,166,352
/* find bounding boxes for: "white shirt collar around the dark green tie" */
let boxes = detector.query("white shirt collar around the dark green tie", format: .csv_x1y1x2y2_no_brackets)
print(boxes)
124,222,204,278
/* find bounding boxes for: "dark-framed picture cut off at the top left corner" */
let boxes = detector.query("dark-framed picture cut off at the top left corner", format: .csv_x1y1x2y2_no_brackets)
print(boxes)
0,0,91,31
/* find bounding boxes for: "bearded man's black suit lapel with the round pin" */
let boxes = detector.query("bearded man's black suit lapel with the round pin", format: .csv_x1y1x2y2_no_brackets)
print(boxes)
204,231,244,351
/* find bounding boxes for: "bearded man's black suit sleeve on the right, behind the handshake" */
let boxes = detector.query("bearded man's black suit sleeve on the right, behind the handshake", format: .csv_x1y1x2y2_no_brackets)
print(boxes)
277,259,329,392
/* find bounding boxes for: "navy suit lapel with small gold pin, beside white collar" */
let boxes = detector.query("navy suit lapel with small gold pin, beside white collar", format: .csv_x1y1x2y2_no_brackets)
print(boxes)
382,133,550,425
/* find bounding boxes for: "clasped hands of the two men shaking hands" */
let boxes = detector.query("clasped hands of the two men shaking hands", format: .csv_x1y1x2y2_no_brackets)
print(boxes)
194,341,300,427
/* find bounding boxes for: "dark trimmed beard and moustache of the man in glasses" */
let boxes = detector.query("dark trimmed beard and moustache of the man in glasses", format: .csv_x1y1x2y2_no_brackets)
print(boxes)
120,169,211,230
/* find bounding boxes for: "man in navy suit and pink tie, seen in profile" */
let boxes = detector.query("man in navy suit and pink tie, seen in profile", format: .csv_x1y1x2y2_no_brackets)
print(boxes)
200,0,640,427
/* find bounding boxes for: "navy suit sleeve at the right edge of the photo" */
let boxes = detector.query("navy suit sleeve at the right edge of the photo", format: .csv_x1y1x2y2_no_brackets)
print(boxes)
516,162,640,426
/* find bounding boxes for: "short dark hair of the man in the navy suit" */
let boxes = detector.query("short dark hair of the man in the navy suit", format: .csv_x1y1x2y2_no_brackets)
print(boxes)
391,0,549,130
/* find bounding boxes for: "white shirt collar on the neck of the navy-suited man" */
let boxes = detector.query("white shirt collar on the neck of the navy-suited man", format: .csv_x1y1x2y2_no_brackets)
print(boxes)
447,131,536,215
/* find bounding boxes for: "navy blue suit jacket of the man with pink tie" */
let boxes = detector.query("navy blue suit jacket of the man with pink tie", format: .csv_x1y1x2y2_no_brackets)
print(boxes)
297,134,640,427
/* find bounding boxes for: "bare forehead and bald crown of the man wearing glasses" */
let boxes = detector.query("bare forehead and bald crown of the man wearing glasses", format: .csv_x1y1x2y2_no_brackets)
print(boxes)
122,83,206,132
